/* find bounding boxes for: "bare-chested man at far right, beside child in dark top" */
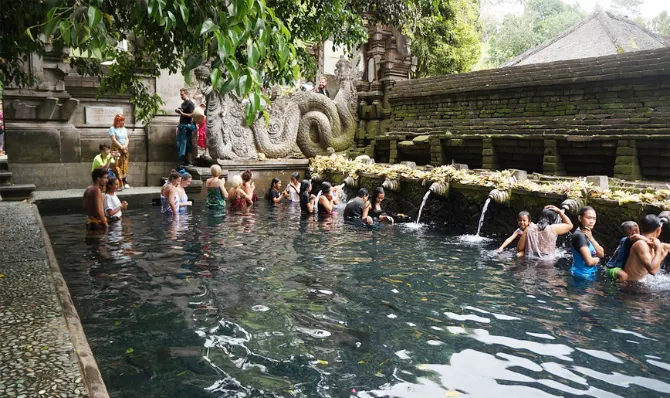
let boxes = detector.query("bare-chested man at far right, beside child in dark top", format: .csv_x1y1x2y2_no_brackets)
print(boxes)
618,214,668,281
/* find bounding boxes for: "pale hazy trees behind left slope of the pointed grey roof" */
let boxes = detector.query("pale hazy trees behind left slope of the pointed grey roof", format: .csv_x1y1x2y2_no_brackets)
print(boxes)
489,0,586,66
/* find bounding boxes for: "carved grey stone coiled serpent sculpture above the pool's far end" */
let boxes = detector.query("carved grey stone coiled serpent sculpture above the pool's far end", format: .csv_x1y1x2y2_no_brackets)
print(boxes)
195,58,357,160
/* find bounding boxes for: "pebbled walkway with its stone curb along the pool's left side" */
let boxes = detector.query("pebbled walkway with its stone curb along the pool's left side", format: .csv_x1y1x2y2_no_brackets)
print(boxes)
0,202,108,398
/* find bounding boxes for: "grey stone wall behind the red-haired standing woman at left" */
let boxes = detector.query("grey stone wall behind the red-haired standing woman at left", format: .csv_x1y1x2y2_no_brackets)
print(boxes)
3,51,183,190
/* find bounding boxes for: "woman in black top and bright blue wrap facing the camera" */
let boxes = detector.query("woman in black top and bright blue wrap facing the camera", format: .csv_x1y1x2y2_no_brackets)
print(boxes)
570,206,605,280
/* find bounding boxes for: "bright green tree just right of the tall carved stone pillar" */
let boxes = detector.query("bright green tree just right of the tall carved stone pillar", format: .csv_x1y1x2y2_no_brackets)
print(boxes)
405,0,480,77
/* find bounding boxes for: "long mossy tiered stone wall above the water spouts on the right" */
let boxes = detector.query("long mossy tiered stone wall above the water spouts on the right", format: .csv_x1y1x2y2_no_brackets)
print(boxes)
378,48,670,180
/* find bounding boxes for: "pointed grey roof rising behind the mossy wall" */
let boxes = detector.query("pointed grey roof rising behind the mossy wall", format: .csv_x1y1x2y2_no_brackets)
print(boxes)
502,11,668,67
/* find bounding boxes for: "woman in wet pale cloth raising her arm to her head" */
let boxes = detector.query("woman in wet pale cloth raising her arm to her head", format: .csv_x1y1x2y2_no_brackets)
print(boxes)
517,205,572,260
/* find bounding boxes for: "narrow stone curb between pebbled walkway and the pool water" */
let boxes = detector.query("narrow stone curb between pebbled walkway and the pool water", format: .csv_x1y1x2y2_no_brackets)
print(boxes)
31,204,109,398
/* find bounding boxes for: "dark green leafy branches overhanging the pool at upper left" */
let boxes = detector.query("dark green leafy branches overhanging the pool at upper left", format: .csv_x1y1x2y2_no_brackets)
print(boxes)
25,0,298,123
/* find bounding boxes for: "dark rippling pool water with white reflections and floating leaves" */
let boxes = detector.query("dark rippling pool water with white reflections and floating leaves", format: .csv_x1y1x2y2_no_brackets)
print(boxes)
43,203,670,398
